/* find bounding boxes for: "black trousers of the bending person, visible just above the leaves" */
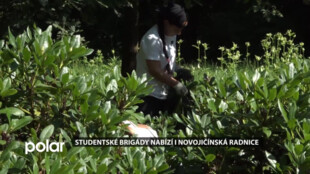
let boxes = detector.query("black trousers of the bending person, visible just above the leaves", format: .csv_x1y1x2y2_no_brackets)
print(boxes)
138,96,166,117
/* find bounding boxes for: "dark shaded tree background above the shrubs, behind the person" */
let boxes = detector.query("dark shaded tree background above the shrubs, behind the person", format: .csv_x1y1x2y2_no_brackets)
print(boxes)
0,0,310,64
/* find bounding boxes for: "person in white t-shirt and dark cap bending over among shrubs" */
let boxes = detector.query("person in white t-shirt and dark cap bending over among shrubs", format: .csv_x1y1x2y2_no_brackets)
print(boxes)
136,3,188,116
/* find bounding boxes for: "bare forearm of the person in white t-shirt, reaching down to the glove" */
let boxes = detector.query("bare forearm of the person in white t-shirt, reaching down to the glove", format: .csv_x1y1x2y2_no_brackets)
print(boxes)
146,60,179,87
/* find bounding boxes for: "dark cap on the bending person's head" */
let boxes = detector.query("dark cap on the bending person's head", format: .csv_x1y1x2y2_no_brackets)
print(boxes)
159,3,187,28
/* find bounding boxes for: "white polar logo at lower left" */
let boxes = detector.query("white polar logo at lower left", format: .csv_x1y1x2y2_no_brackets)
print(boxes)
25,140,65,154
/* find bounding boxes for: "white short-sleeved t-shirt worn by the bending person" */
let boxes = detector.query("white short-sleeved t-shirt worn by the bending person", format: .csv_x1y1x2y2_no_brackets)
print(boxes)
136,25,176,99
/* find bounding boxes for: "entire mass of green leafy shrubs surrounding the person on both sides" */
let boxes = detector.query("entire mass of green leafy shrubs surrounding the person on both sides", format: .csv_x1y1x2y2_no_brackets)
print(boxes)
0,27,310,174
